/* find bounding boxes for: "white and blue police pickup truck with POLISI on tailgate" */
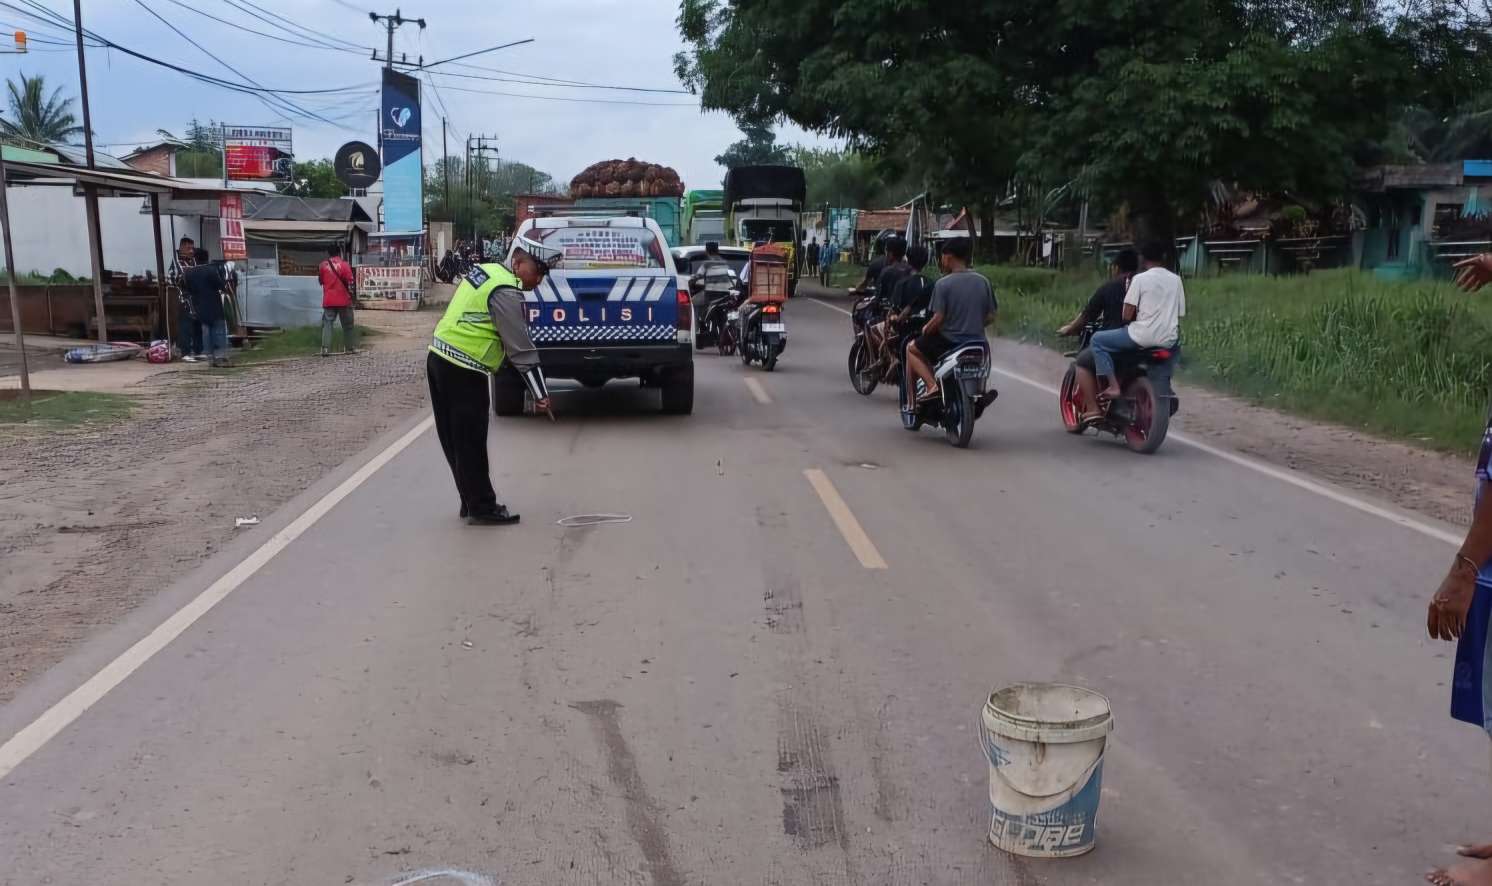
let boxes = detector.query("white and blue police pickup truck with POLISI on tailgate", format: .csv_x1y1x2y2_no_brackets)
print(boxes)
492,216,694,415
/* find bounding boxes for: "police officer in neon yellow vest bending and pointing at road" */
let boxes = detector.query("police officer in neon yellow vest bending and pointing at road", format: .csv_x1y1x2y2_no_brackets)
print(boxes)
425,237,562,527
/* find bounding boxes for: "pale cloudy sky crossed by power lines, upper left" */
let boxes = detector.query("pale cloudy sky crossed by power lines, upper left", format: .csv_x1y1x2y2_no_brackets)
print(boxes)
0,0,828,188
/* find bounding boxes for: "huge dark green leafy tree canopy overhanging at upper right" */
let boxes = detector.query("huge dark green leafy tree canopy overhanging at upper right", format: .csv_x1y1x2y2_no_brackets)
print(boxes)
676,0,1492,258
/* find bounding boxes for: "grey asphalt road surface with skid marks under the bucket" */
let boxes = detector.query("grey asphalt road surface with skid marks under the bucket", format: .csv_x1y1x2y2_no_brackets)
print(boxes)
0,286,1492,886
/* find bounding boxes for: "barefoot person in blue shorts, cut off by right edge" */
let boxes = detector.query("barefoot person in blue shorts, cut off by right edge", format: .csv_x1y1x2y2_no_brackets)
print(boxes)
1425,246,1492,886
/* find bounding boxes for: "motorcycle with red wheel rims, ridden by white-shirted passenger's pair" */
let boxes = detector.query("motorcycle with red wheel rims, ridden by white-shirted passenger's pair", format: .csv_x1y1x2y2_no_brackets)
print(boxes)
1058,324,1182,455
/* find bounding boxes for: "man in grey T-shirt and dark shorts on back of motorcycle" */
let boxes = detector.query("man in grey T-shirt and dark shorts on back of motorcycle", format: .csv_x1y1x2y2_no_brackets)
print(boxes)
907,237,998,403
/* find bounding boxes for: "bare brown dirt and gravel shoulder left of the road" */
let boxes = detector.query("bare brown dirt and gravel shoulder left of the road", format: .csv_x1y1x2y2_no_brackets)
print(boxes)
0,310,439,704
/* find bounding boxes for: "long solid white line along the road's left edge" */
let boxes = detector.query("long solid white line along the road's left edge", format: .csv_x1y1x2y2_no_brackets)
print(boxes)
0,416,436,780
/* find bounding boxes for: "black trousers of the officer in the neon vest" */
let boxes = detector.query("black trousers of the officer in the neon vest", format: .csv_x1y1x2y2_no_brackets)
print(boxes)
425,354,497,513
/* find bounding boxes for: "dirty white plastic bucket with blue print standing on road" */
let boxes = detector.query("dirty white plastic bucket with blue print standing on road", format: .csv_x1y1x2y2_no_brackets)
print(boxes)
979,683,1113,858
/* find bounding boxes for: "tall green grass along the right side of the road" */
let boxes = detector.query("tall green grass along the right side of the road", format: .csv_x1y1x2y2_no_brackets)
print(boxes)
980,267,1492,452
